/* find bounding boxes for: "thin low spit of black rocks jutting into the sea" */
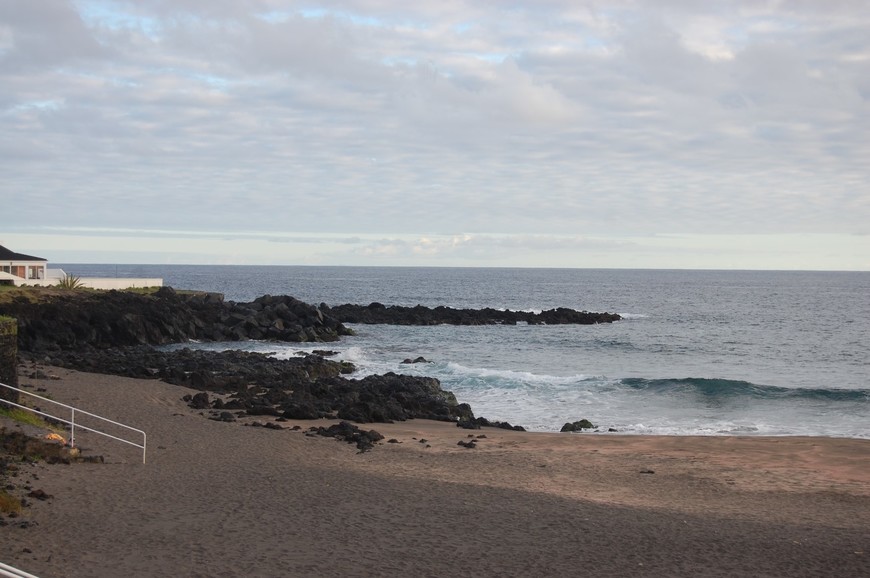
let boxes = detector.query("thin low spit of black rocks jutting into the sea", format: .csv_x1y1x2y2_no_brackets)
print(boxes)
320,303,622,325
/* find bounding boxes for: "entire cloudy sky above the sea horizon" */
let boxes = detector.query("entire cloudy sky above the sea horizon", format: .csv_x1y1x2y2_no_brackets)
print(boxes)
0,0,870,271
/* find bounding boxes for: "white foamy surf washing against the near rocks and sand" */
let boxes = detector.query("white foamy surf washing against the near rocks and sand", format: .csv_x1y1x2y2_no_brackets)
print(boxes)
179,335,870,438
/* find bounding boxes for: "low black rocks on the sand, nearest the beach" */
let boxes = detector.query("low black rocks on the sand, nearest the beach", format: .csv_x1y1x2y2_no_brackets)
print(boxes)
42,346,475,423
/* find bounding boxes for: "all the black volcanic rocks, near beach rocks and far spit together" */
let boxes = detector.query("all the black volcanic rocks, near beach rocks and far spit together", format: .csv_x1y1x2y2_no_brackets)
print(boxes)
0,287,619,430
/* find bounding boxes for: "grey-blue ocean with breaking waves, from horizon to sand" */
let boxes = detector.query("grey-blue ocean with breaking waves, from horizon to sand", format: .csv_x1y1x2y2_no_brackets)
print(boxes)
60,264,870,438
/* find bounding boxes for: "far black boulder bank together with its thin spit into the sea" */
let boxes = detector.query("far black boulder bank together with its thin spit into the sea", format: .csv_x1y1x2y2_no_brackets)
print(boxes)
0,287,621,352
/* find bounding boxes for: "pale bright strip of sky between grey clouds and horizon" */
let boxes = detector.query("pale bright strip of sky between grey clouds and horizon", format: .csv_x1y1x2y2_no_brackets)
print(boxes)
0,228,870,270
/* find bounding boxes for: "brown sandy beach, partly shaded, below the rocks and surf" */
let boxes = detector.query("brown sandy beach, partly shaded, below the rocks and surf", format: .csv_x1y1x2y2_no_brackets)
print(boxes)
0,368,870,578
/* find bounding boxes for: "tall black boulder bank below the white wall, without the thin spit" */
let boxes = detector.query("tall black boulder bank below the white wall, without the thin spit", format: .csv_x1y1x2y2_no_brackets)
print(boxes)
0,287,351,352
